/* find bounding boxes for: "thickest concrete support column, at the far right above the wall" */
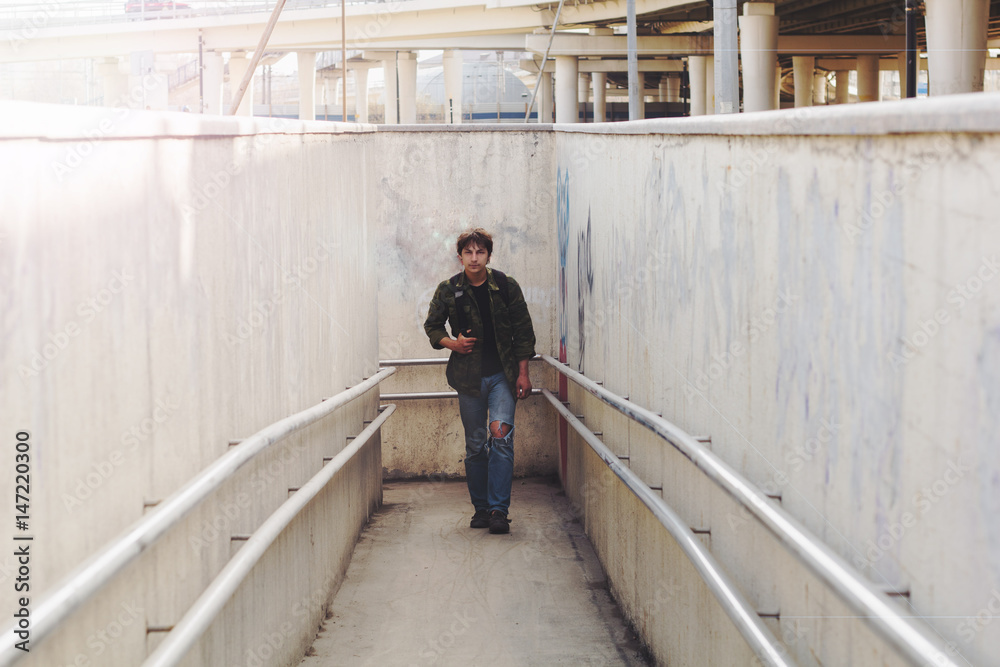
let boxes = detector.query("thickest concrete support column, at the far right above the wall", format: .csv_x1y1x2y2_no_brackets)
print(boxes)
926,0,990,95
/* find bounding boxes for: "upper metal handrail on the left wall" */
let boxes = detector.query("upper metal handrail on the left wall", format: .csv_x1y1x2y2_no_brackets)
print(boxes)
0,367,396,667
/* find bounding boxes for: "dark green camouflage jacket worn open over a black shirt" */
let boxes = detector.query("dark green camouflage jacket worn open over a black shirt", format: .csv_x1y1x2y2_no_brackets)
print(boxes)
424,268,535,396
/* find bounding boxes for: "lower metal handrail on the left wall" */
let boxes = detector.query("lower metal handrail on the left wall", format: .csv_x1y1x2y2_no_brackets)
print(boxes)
142,404,396,667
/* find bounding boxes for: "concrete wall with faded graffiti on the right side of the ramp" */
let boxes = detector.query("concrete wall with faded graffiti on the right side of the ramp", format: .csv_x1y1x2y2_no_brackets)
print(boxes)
556,95,1000,665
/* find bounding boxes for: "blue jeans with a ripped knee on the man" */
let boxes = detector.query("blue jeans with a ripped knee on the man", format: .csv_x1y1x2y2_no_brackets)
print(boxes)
458,373,516,514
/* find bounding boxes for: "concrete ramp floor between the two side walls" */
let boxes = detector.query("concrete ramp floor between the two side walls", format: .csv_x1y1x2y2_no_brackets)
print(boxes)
301,479,650,667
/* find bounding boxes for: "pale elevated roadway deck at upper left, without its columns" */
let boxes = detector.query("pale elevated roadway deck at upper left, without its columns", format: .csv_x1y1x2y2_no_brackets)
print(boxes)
0,0,682,62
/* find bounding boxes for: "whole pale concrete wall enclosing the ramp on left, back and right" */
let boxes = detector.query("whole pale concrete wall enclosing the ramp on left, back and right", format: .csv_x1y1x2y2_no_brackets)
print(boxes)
0,95,1000,665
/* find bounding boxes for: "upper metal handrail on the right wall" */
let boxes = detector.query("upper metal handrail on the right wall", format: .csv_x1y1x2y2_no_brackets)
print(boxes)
541,354,958,667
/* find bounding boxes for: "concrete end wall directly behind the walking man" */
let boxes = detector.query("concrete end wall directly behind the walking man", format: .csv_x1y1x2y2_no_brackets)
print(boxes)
367,126,558,480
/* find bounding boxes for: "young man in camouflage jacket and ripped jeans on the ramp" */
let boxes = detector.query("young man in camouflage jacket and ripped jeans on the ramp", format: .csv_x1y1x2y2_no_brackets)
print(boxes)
424,228,535,533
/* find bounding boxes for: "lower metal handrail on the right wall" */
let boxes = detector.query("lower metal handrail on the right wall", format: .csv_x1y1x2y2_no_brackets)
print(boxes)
542,389,795,665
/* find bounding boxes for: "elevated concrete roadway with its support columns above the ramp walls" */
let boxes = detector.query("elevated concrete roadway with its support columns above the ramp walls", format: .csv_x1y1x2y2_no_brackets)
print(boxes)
0,0,1000,123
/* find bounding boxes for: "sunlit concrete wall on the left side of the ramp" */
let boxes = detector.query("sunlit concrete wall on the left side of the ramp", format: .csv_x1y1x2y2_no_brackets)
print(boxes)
0,104,381,666
